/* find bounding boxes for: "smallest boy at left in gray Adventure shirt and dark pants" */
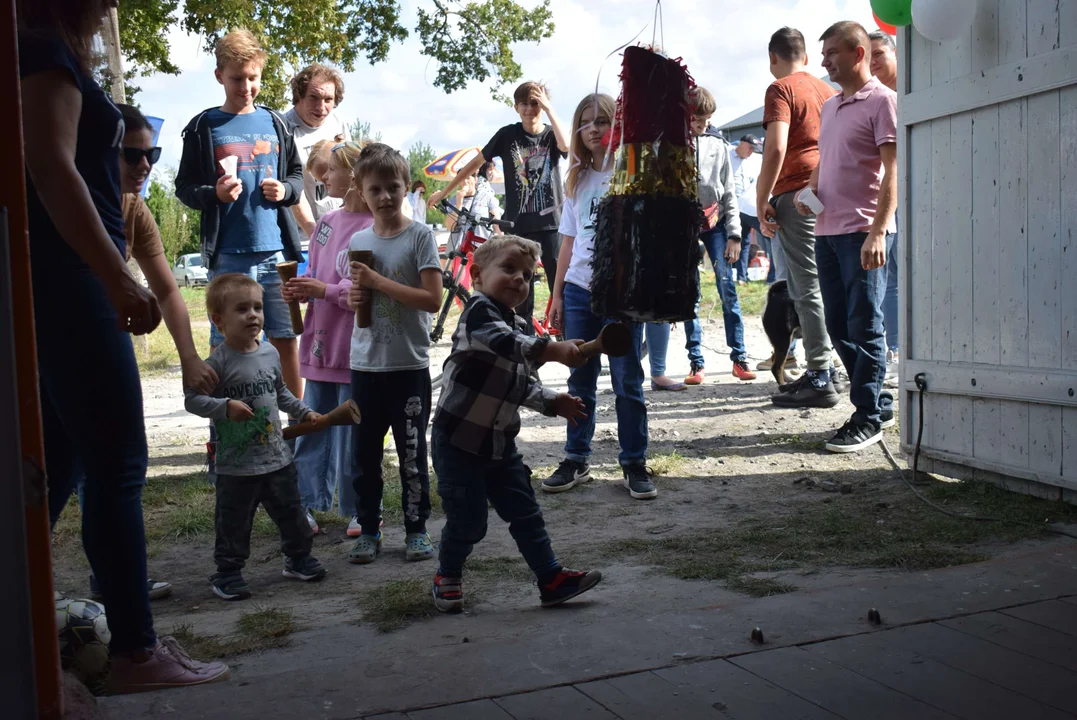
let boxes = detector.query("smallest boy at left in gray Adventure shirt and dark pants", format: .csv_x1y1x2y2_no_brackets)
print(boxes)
184,273,325,599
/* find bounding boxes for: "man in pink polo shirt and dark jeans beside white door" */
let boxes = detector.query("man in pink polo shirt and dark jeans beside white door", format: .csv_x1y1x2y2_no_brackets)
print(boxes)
797,23,897,452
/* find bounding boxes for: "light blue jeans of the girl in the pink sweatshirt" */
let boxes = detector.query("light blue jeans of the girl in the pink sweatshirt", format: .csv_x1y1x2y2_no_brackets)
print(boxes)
295,380,359,518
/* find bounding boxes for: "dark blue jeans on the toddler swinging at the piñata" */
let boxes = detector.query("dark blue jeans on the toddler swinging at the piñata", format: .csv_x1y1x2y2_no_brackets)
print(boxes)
430,425,558,578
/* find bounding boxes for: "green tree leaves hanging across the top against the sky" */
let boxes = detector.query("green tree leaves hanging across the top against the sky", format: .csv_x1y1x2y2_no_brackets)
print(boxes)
120,0,554,109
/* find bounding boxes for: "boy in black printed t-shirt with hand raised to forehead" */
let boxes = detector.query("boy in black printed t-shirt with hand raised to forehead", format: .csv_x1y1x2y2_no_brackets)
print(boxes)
430,82,569,333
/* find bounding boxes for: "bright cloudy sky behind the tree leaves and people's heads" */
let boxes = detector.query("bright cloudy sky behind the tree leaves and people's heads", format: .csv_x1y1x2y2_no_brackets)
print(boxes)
135,0,876,172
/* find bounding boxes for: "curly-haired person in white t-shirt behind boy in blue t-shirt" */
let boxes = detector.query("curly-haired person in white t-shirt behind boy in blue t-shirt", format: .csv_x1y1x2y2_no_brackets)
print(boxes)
284,62,347,237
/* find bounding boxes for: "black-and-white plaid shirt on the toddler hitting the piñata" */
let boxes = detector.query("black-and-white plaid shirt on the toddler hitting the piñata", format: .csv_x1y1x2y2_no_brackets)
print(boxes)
433,293,557,460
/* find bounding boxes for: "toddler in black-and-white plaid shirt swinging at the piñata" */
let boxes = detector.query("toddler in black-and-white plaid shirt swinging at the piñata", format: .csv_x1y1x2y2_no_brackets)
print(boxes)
431,235,602,612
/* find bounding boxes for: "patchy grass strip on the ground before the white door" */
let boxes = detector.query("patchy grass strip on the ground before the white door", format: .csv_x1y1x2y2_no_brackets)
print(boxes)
604,482,1077,597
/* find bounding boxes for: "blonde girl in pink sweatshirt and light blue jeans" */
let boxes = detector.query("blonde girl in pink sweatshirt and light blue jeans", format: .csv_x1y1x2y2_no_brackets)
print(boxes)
281,141,374,536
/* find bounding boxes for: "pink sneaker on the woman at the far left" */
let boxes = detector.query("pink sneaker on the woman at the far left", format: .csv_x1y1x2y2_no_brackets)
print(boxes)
107,637,228,695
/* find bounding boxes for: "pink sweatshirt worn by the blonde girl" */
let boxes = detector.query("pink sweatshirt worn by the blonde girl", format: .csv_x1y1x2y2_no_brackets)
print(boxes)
299,209,374,383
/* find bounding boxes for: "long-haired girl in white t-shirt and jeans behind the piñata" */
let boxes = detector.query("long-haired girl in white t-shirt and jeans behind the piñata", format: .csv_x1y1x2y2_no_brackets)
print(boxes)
542,94,658,499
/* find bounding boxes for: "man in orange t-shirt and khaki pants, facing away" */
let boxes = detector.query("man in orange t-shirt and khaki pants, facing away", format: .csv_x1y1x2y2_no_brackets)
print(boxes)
756,28,840,408
